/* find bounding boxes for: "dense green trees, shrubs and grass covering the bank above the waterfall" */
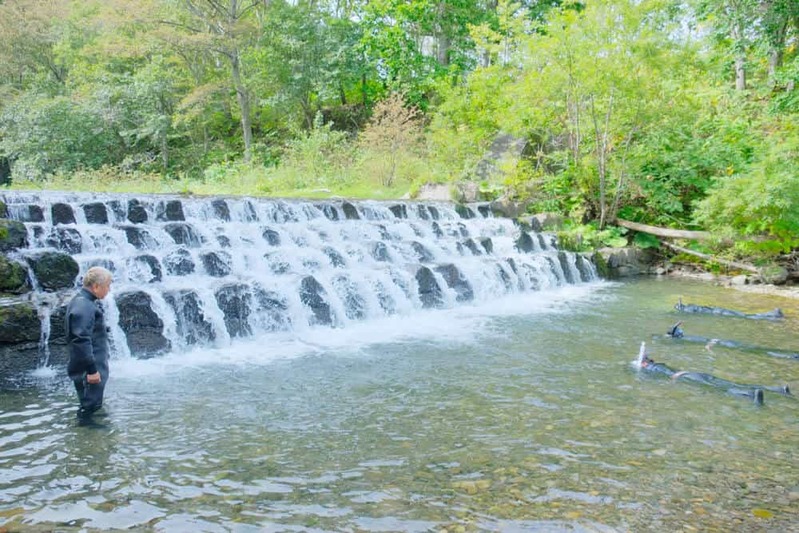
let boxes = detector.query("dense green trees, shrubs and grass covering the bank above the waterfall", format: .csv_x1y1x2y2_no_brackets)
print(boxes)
0,0,799,266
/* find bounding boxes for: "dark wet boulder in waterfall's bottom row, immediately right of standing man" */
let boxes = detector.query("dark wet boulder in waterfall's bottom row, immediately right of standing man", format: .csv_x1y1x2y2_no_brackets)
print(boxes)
115,291,171,358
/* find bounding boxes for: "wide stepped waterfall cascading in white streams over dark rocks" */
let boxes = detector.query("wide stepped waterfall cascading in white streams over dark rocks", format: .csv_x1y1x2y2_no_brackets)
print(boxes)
2,192,597,357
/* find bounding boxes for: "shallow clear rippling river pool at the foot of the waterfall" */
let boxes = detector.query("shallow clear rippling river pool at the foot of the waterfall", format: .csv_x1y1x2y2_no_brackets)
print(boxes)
0,279,799,531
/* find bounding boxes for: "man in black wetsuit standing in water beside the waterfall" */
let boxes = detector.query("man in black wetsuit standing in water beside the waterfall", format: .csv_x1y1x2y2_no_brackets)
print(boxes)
66,267,113,419
